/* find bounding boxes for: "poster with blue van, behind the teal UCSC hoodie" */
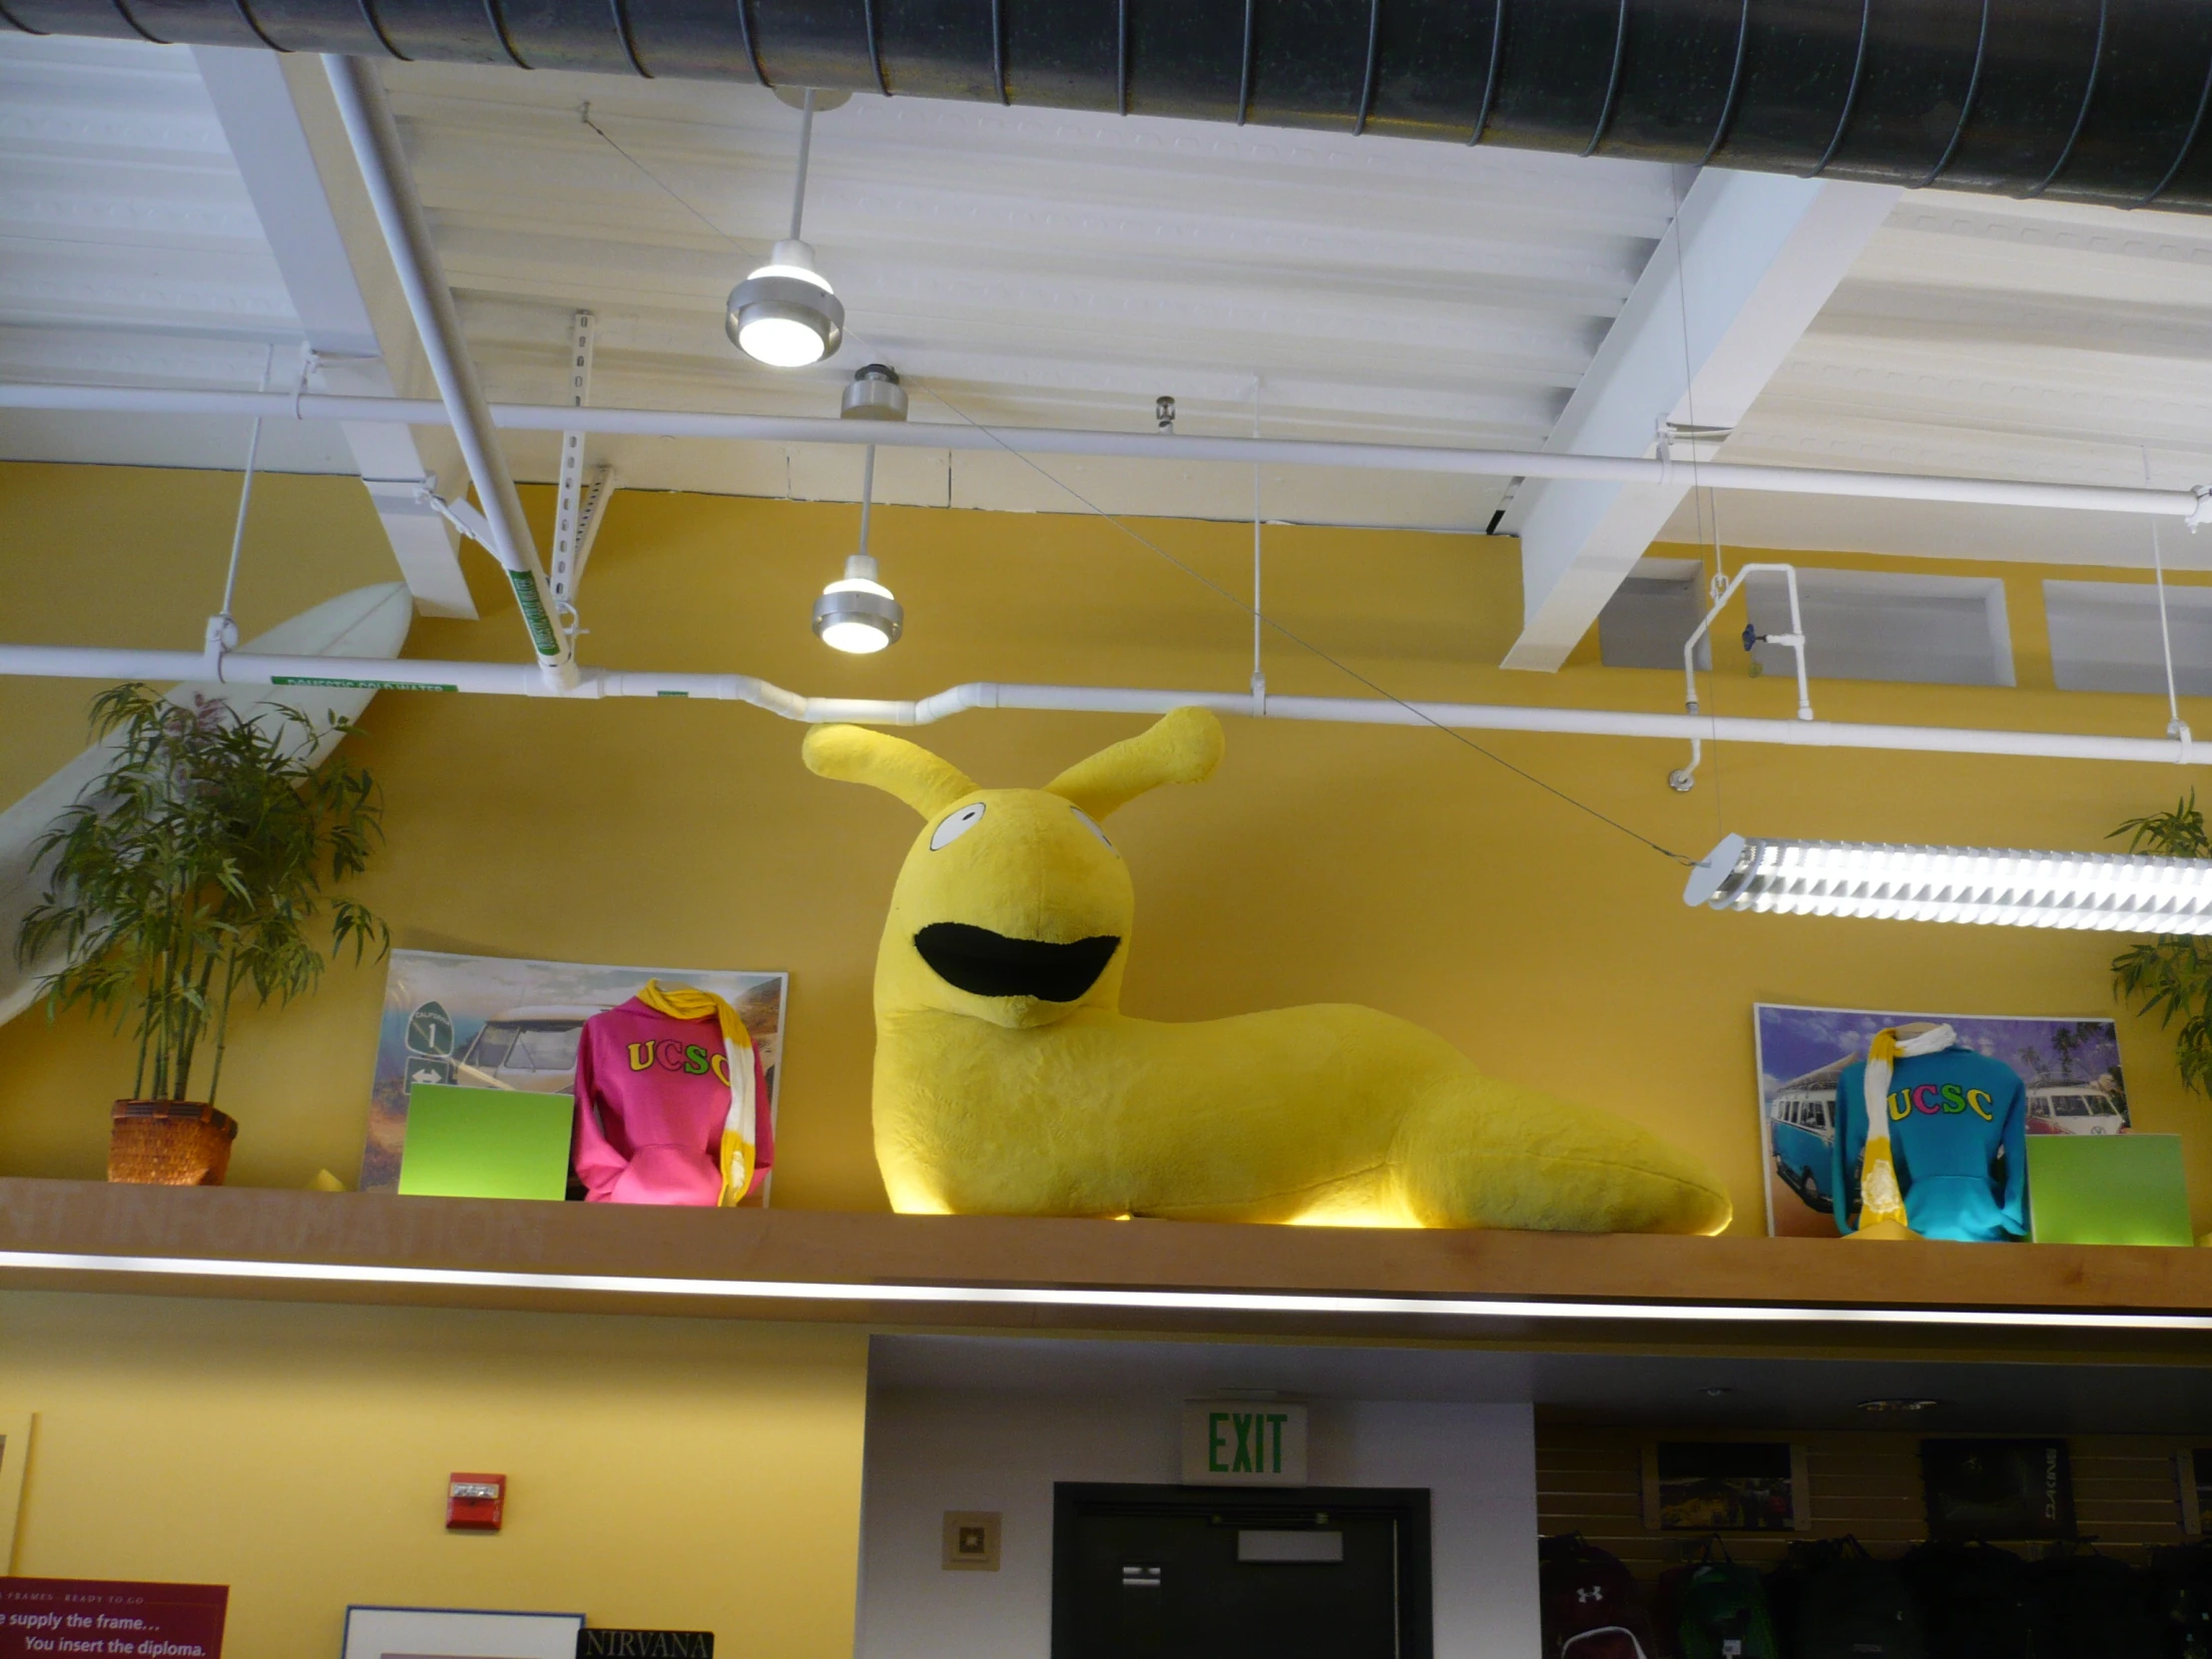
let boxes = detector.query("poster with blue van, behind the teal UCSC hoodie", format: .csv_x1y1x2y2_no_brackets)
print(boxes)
1752,1002,2128,1239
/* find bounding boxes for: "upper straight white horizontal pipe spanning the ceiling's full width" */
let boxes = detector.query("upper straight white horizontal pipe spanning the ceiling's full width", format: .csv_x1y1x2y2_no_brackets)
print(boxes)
0,385,2212,526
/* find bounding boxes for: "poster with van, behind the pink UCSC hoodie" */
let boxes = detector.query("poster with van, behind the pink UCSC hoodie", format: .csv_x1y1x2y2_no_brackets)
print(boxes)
360,951,792,1206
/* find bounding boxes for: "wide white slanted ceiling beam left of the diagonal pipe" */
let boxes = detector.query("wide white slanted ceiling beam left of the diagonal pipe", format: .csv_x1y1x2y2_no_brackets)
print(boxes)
193,47,475,617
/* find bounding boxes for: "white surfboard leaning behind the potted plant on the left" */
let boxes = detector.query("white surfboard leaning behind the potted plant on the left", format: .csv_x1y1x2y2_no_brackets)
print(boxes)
0,582,413,1024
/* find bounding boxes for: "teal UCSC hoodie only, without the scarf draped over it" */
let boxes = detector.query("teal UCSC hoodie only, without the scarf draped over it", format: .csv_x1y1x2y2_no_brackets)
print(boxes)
1830,1048,2028,1241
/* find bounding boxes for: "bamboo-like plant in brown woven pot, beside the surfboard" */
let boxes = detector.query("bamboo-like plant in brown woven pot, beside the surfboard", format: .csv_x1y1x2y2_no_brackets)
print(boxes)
16,686,389,1186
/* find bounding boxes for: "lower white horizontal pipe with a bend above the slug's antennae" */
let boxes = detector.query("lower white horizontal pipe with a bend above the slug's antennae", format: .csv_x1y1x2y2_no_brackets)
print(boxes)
0,646,2199,766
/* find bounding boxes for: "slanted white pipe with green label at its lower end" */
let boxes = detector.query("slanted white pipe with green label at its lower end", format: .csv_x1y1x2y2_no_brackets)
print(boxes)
323,55,575,686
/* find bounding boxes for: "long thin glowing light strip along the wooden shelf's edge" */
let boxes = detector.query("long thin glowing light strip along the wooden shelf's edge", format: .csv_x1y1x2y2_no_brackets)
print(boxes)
0,1250,2212,1332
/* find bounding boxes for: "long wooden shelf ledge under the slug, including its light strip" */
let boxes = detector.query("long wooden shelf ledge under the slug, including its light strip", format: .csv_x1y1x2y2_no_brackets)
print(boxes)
0,1179,2212,1361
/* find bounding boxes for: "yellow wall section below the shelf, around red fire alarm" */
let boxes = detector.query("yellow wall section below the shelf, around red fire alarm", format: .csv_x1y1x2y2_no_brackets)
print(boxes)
0,1292,867,1659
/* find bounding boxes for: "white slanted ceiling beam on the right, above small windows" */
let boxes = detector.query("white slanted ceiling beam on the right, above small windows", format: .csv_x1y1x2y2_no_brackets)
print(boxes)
1504,171,1898,673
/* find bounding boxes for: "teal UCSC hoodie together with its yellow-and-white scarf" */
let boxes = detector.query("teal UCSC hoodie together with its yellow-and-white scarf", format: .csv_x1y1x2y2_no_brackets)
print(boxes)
1830,1024,2028,1243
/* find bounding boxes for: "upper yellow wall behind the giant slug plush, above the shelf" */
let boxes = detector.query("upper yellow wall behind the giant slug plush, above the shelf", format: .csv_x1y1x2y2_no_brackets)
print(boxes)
0,467,2212,1230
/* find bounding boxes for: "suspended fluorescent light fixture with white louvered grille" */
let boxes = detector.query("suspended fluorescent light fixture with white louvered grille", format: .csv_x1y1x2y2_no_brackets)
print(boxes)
1681,836,2212,933
